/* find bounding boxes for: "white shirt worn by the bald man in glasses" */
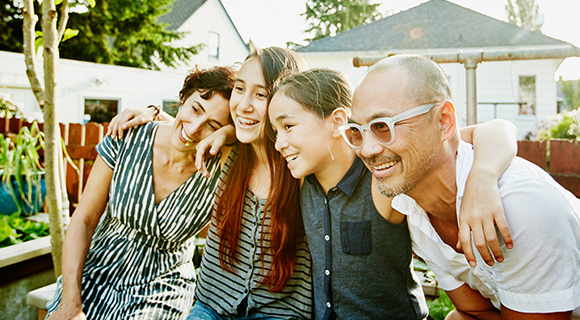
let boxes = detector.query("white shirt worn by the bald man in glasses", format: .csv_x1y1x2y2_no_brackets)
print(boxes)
392,142,580,319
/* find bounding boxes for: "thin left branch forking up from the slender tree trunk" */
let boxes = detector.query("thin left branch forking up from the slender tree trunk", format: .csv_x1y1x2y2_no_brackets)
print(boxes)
22,0,44,109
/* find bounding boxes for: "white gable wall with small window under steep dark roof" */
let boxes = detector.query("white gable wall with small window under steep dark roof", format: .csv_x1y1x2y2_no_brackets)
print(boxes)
161,0,249,71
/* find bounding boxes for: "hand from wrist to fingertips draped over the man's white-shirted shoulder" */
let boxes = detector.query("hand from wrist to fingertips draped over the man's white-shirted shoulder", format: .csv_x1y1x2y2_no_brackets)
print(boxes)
457,169,513,266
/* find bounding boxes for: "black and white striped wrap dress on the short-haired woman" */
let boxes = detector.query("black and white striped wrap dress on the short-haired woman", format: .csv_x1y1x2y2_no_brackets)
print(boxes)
47,123,220,320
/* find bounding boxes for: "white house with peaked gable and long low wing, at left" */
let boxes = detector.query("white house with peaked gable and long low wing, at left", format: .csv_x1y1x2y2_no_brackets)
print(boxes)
0,0,249,123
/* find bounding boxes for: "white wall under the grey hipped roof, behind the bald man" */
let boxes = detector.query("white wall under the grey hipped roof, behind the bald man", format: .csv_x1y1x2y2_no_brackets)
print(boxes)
301,52,561,139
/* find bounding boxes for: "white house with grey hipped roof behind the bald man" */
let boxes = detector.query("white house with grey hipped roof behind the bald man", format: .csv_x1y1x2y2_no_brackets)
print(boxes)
297,0,573,139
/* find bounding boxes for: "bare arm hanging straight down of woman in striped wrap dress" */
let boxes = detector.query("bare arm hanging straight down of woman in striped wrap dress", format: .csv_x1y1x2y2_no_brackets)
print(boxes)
48,156,113,320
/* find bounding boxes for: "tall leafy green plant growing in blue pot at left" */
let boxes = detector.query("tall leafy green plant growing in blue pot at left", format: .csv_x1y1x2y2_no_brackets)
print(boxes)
0,122,44,213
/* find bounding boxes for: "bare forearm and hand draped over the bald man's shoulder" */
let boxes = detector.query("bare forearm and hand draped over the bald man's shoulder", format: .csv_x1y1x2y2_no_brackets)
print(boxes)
457,119,517,266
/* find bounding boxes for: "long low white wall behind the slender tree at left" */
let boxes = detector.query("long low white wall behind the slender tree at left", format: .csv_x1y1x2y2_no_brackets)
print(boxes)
0,51,185,123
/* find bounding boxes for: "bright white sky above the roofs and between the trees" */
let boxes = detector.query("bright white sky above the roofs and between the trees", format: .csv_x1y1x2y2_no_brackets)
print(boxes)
221,0,580,80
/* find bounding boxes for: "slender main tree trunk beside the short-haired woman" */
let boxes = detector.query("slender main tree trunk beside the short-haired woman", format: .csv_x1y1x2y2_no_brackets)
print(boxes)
42,0,64,277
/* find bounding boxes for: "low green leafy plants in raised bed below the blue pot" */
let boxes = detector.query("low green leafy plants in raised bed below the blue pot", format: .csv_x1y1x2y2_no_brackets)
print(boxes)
0,213,49,248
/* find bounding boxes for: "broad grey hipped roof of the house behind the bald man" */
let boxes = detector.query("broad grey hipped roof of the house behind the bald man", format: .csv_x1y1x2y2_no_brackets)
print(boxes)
297,0,571,52
